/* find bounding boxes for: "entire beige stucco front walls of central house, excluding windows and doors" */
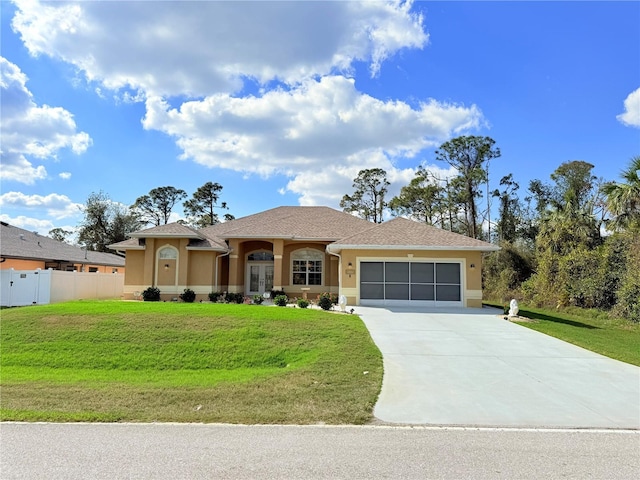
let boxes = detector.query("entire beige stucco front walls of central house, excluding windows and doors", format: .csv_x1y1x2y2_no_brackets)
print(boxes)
119,234,482,307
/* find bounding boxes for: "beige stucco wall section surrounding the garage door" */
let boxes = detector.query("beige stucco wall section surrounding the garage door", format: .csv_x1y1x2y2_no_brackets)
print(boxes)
340,250,482,307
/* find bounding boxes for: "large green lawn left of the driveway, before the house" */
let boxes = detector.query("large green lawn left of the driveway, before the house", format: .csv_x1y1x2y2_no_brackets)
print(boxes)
0,301,382,424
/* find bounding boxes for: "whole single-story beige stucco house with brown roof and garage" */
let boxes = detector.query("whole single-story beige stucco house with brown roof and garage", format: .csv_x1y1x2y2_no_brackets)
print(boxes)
110,207,499,307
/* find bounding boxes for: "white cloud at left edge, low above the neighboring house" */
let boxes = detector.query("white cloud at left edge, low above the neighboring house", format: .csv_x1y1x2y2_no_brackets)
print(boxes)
0,57,91,184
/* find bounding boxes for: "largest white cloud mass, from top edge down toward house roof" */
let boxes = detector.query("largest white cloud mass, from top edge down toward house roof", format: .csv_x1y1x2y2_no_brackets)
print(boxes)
6,0,485,206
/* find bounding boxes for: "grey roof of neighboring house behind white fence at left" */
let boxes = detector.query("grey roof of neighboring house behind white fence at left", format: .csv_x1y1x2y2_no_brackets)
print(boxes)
0,222,124,267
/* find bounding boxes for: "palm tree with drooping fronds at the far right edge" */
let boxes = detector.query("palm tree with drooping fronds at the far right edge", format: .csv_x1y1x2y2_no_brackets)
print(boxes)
602,156,640,230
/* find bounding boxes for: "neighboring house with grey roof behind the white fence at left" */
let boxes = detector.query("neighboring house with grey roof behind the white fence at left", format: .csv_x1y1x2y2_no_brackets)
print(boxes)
0,222,125,273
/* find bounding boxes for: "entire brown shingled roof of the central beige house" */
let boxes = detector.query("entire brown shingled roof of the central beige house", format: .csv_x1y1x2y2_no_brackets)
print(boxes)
109,207,499,252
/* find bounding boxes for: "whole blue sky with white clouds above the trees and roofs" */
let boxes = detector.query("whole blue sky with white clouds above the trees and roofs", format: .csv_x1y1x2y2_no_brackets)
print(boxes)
0,1,640,238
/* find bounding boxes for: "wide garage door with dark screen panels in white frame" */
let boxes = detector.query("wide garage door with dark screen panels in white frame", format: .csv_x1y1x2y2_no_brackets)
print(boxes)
360,261,462,306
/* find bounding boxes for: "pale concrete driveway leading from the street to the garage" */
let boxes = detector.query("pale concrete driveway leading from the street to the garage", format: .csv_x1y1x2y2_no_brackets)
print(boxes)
356,307,640,429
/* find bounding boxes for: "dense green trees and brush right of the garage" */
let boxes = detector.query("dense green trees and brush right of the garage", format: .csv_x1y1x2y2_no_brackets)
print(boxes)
483,157,640,322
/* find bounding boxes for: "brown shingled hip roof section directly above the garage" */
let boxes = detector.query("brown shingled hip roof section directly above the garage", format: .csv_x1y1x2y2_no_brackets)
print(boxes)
327,218,500,252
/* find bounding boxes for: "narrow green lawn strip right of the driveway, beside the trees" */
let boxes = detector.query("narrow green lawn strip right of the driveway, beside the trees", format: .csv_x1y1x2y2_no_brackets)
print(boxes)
485,302,640,366
